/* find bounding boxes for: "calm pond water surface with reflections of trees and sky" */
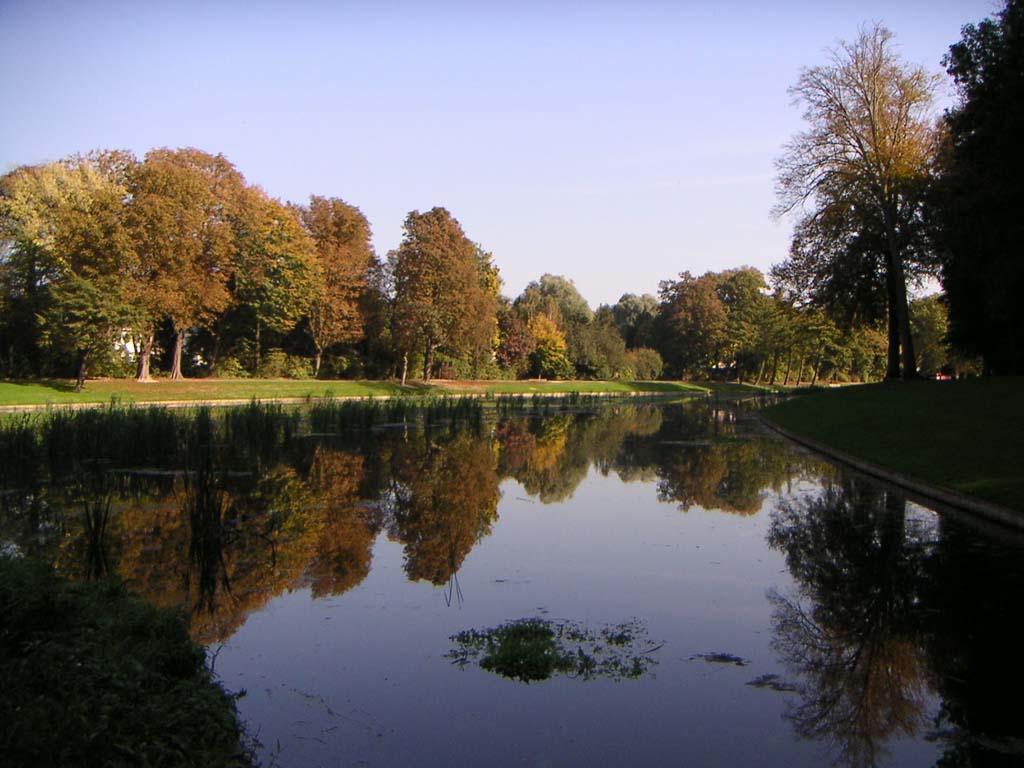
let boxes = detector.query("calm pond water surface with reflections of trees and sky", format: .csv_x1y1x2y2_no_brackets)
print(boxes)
0,402,1024,766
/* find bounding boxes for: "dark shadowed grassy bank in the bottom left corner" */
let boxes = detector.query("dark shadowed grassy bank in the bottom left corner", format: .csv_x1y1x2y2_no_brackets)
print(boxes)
0,556,253,767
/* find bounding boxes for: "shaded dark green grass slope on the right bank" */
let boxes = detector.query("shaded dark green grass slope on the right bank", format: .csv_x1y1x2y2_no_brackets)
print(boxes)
764,377,1024,512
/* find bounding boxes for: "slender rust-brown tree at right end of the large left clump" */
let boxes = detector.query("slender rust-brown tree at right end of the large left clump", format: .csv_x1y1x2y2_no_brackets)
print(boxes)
300,196,377,376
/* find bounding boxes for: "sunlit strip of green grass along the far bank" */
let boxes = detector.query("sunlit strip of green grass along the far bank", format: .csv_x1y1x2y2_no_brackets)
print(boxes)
0,379,707,406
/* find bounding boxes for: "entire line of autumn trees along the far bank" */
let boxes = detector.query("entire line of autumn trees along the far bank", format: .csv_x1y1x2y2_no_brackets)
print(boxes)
0,148,913,386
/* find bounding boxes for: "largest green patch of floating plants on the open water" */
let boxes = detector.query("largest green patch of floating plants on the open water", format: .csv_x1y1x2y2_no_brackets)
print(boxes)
445,618,664,683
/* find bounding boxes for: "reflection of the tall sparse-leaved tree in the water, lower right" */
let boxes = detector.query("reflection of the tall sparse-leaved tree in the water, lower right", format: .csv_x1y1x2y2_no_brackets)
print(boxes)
769,480,931,766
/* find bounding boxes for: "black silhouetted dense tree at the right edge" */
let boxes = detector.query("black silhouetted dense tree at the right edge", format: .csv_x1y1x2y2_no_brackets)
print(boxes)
938,0,1024,374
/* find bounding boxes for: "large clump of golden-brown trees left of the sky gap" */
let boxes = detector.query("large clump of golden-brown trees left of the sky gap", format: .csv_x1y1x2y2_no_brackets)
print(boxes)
0,148,375,386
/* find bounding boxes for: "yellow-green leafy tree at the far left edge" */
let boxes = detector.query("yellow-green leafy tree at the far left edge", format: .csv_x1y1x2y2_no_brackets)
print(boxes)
0,153,134,389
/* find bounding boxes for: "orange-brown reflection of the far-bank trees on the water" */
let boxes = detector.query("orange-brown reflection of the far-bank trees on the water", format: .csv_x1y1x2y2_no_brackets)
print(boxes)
0,403,815,642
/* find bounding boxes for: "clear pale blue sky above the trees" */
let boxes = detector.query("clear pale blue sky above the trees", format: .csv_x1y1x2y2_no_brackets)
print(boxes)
0,0,997,306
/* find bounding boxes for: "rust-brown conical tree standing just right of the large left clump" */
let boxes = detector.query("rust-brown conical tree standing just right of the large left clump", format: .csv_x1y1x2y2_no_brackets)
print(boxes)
389,208,497,384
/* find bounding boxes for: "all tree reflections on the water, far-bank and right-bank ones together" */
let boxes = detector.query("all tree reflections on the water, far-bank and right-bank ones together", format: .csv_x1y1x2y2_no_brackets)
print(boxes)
0,403,1024,766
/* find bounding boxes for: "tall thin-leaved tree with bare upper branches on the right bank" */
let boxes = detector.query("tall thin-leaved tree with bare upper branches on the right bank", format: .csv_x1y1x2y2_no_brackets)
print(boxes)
776,25,936,378
